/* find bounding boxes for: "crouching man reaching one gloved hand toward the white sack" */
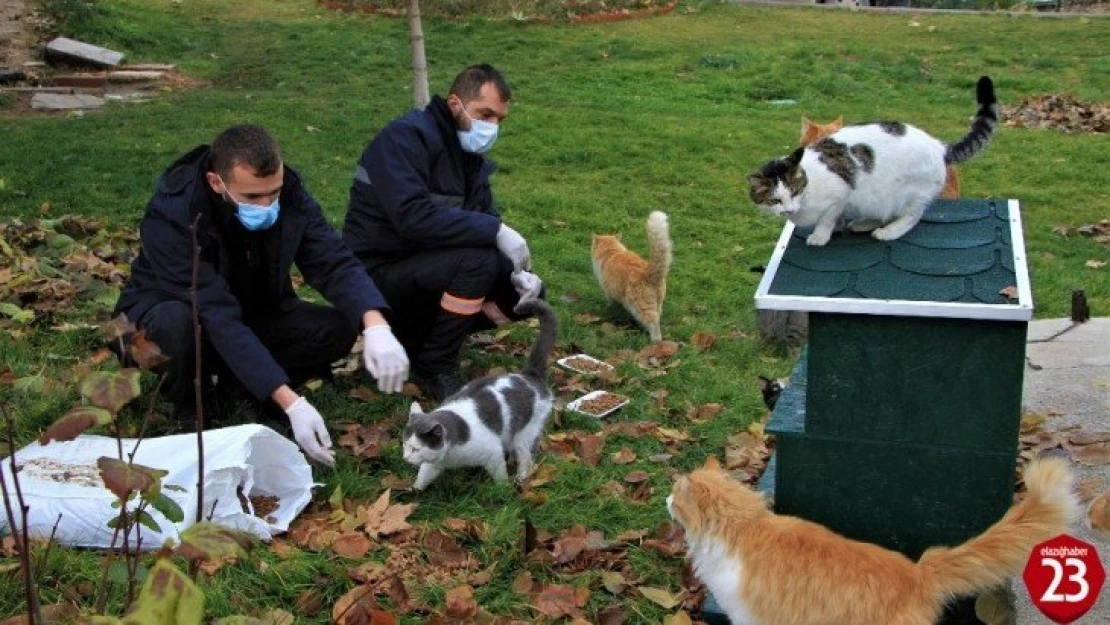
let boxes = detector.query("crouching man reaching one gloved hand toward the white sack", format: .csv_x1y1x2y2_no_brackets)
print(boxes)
115,125,408,465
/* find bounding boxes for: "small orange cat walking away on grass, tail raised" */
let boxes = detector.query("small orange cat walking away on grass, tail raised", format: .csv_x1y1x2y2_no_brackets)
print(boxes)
589,211,672,341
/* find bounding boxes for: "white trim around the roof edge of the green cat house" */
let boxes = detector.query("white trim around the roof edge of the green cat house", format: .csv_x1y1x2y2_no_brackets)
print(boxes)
755,200,1033,321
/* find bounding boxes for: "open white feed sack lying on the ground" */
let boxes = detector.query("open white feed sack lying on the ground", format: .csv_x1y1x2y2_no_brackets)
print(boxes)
0,425,313,550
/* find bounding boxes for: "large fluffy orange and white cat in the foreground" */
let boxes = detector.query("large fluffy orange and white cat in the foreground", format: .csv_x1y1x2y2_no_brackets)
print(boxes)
667,458,1079,625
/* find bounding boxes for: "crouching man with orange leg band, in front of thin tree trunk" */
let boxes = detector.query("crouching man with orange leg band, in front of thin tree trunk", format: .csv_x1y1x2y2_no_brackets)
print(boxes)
343,64,544,400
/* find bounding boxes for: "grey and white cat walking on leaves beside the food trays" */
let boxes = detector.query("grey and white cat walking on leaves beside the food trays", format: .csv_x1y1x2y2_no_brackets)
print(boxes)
403,300,558,491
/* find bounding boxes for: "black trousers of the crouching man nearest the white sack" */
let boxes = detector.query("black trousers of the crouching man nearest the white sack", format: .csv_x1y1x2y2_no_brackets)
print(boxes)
127,299,357,414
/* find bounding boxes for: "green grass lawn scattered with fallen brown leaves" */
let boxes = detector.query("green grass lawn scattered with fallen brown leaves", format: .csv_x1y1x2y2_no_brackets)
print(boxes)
0,0,1110,623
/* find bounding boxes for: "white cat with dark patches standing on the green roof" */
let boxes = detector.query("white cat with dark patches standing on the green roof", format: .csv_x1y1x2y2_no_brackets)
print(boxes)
748,77,998,245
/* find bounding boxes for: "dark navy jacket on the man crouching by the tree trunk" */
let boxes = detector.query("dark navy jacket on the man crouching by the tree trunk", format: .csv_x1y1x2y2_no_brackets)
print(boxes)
343,95,501,269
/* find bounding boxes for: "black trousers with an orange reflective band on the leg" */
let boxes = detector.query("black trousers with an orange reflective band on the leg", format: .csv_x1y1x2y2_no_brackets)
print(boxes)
366,248,539,375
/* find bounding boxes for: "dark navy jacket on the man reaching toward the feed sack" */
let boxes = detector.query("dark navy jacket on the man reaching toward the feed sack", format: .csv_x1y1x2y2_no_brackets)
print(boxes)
114,145,387,399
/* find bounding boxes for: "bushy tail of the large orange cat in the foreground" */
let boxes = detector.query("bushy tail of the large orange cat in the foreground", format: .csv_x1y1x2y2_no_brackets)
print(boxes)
917,457,1080,601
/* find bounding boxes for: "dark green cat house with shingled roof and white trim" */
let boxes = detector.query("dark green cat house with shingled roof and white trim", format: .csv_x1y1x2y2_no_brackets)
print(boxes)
705,200,1033,623
